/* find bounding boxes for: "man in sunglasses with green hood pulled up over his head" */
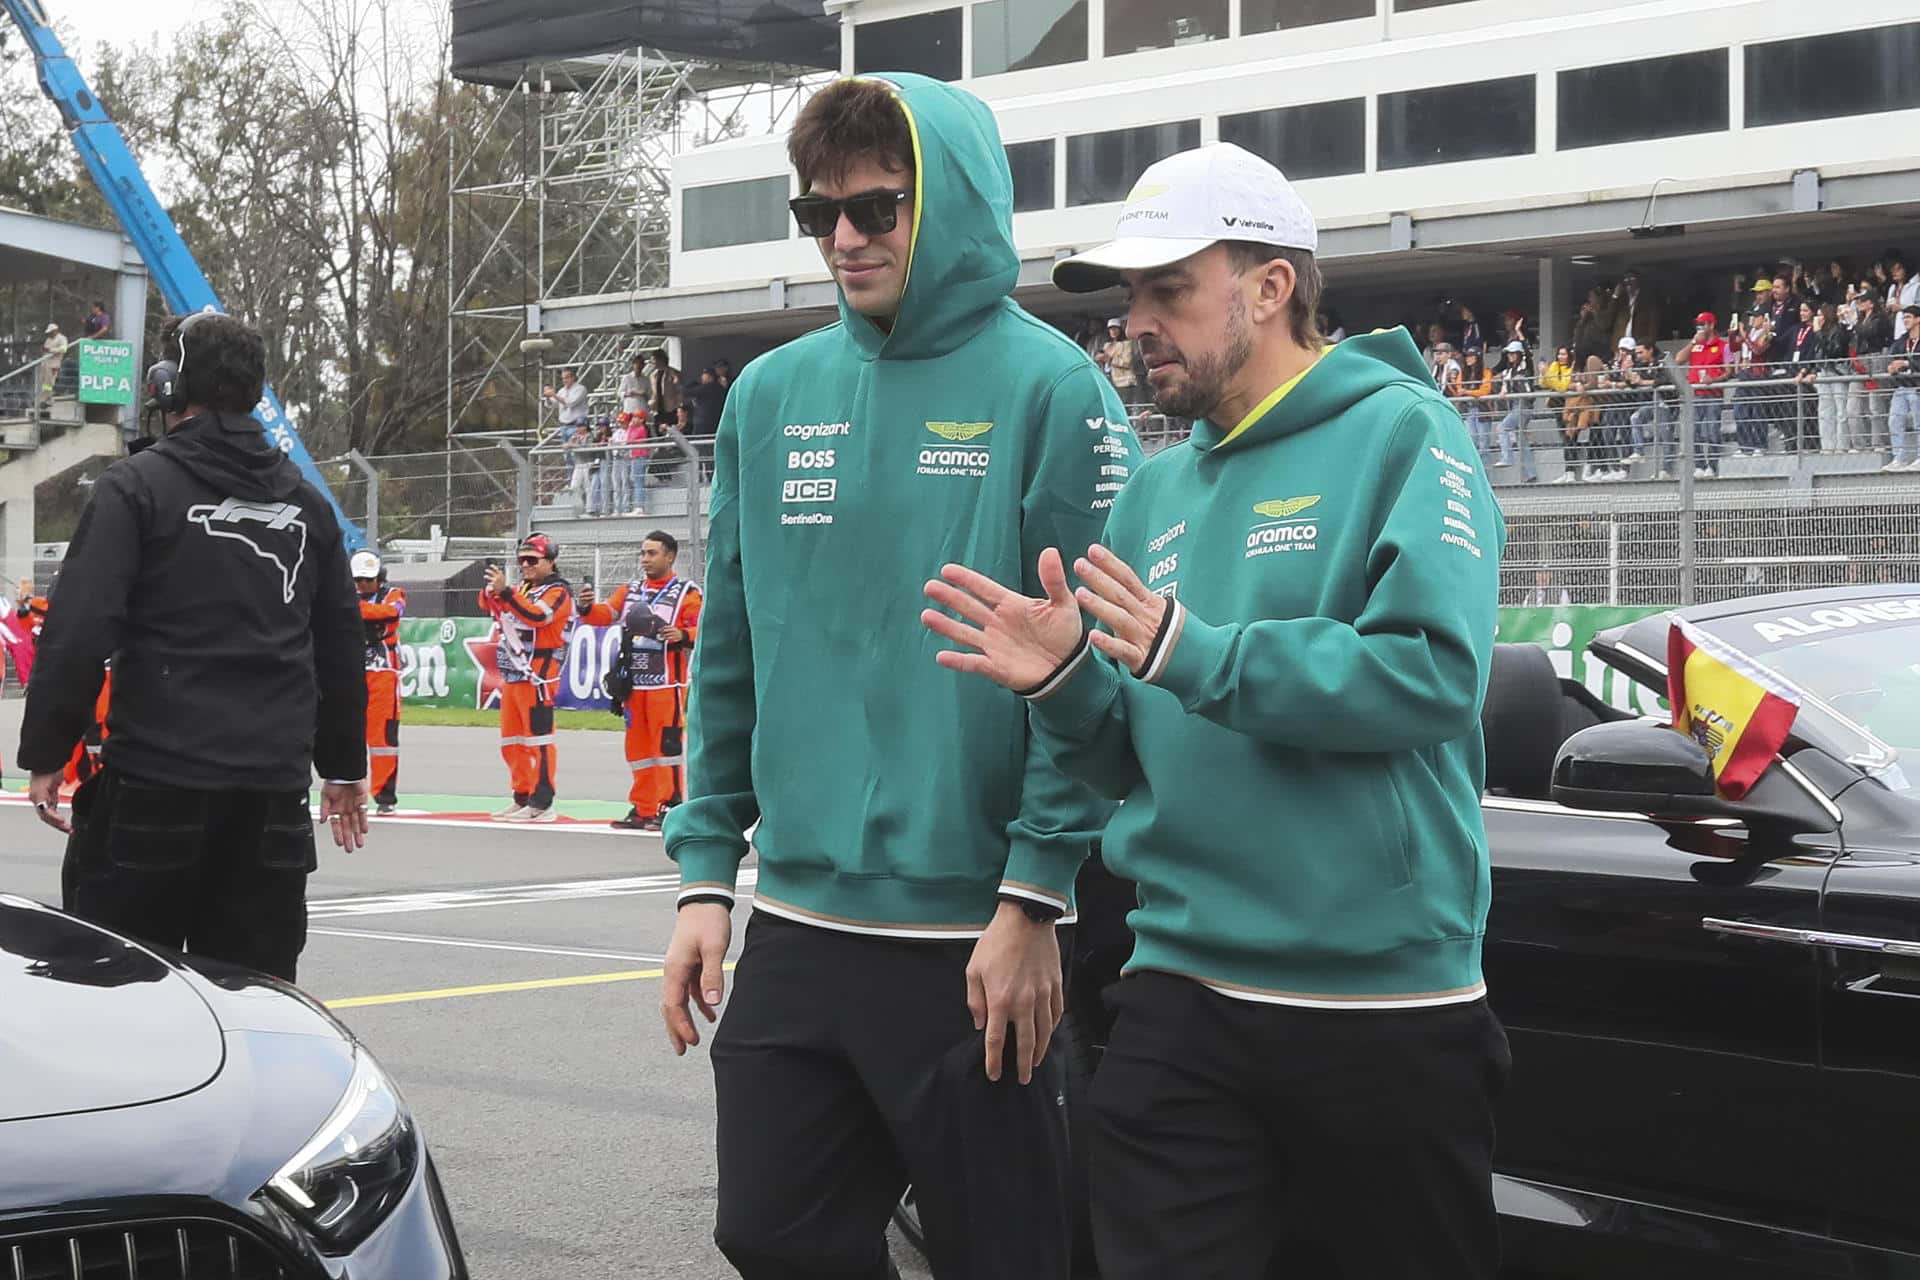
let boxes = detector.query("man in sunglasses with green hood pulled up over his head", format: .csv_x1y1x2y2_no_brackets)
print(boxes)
662,75,1139,1280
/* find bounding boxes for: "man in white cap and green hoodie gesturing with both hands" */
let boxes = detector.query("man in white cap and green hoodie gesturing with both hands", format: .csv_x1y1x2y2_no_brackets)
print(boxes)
924,144,1509,1280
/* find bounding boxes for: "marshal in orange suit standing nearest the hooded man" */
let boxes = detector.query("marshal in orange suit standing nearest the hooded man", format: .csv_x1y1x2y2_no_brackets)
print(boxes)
580,530,701,831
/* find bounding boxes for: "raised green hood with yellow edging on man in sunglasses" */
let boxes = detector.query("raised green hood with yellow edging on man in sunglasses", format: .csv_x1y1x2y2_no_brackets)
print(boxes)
841,71,1020,361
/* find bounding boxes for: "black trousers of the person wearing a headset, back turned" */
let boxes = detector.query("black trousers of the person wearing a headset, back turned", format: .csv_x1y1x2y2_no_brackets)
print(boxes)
60,768,319,983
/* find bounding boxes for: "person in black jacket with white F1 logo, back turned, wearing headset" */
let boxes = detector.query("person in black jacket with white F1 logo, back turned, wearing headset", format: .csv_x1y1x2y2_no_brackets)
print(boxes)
19,313,367,981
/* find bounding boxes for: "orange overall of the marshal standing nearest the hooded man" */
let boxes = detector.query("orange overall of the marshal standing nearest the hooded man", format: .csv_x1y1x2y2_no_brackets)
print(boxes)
580,574,701,818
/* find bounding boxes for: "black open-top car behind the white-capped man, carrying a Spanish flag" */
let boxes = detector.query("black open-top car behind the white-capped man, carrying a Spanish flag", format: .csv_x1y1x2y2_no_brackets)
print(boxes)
899,587,1920,1280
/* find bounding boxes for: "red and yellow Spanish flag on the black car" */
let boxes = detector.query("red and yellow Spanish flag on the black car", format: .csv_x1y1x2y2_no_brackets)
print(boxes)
1667,614,1799,800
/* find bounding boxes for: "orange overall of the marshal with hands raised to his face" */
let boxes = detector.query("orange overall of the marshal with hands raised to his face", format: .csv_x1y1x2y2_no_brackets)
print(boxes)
480,576,574,810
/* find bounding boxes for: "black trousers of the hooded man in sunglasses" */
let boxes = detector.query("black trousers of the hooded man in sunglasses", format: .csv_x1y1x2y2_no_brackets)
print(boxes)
712,912,1071,1280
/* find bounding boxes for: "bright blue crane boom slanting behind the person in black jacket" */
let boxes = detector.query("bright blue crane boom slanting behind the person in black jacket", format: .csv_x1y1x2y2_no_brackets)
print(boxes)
0,0,367,551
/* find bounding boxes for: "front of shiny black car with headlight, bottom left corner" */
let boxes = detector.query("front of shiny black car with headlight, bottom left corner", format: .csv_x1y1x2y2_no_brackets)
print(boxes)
0,894,467,1280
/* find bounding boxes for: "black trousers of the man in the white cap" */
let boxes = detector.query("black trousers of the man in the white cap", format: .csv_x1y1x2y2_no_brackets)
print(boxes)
1092,973,1511,1280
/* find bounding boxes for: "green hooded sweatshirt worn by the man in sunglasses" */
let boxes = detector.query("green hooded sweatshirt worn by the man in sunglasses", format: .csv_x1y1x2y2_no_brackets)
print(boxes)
666,75,1139,938
